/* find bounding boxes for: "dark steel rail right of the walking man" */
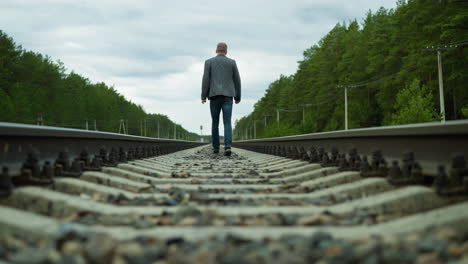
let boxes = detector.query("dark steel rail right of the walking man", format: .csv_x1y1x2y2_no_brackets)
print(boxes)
233,120,468,176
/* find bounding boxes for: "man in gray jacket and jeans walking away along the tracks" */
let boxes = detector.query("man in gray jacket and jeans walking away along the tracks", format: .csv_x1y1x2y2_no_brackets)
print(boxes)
201,42,241,156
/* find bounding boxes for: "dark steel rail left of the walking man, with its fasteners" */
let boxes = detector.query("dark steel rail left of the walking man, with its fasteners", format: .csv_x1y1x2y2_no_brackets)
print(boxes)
0,122,206,181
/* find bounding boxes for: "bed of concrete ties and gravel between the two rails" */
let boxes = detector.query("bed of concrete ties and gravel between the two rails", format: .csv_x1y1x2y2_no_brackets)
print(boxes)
0,146,468,263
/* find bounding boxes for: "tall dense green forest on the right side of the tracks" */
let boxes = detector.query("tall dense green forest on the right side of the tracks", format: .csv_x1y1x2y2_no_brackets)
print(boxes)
234,0,468,139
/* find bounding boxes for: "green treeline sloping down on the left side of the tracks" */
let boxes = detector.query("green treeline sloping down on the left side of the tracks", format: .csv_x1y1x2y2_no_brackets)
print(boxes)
0,30,199,140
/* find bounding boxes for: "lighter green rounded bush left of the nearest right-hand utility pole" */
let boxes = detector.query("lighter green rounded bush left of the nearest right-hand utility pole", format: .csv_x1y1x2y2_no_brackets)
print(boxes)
392,79,440,125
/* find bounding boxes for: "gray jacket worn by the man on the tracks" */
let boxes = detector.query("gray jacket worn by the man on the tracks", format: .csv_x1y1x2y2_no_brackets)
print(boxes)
201,54,241,101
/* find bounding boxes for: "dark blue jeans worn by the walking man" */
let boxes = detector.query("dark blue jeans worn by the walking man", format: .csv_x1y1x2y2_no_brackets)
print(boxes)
210,96,232,151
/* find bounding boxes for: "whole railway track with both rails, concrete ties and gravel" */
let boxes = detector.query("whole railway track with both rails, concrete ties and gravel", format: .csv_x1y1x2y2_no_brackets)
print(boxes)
0,122,468,263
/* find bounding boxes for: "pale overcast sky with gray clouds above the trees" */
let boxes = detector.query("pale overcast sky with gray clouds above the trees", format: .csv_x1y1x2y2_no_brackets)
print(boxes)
0,0,396,134
